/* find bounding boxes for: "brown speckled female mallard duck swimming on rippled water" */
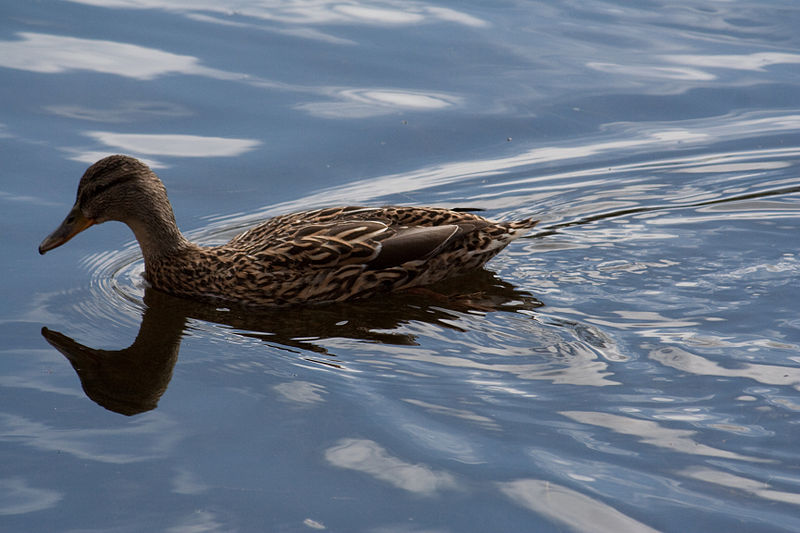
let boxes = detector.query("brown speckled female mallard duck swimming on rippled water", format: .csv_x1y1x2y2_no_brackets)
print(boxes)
39,155,536,307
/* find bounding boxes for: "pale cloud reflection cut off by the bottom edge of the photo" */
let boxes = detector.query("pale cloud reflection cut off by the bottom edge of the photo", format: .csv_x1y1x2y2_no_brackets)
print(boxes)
498,479,657,533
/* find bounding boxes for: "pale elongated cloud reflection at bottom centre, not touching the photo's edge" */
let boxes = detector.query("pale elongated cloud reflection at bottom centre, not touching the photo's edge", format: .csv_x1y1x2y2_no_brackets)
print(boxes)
325,439,456,496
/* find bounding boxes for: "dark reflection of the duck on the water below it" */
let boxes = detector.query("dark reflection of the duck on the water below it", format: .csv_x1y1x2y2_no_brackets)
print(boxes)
42,270,543,416
